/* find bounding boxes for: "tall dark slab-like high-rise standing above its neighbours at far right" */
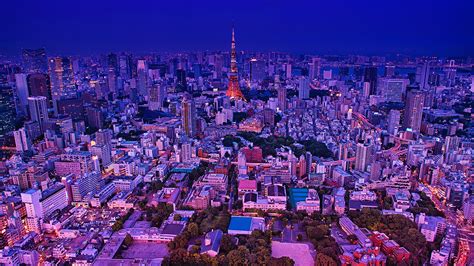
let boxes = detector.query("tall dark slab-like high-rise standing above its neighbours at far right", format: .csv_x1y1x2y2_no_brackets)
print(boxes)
403,90,425,132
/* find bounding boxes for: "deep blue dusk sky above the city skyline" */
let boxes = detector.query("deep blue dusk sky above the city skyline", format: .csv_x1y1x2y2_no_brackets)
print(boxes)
0,0,474,56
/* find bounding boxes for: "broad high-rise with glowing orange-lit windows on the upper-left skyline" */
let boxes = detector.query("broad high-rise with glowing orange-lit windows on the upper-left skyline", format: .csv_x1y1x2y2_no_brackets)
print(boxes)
49,57,77,101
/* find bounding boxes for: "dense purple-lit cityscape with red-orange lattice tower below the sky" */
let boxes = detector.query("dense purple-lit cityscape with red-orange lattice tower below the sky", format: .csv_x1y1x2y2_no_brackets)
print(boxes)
0,2,474,266
